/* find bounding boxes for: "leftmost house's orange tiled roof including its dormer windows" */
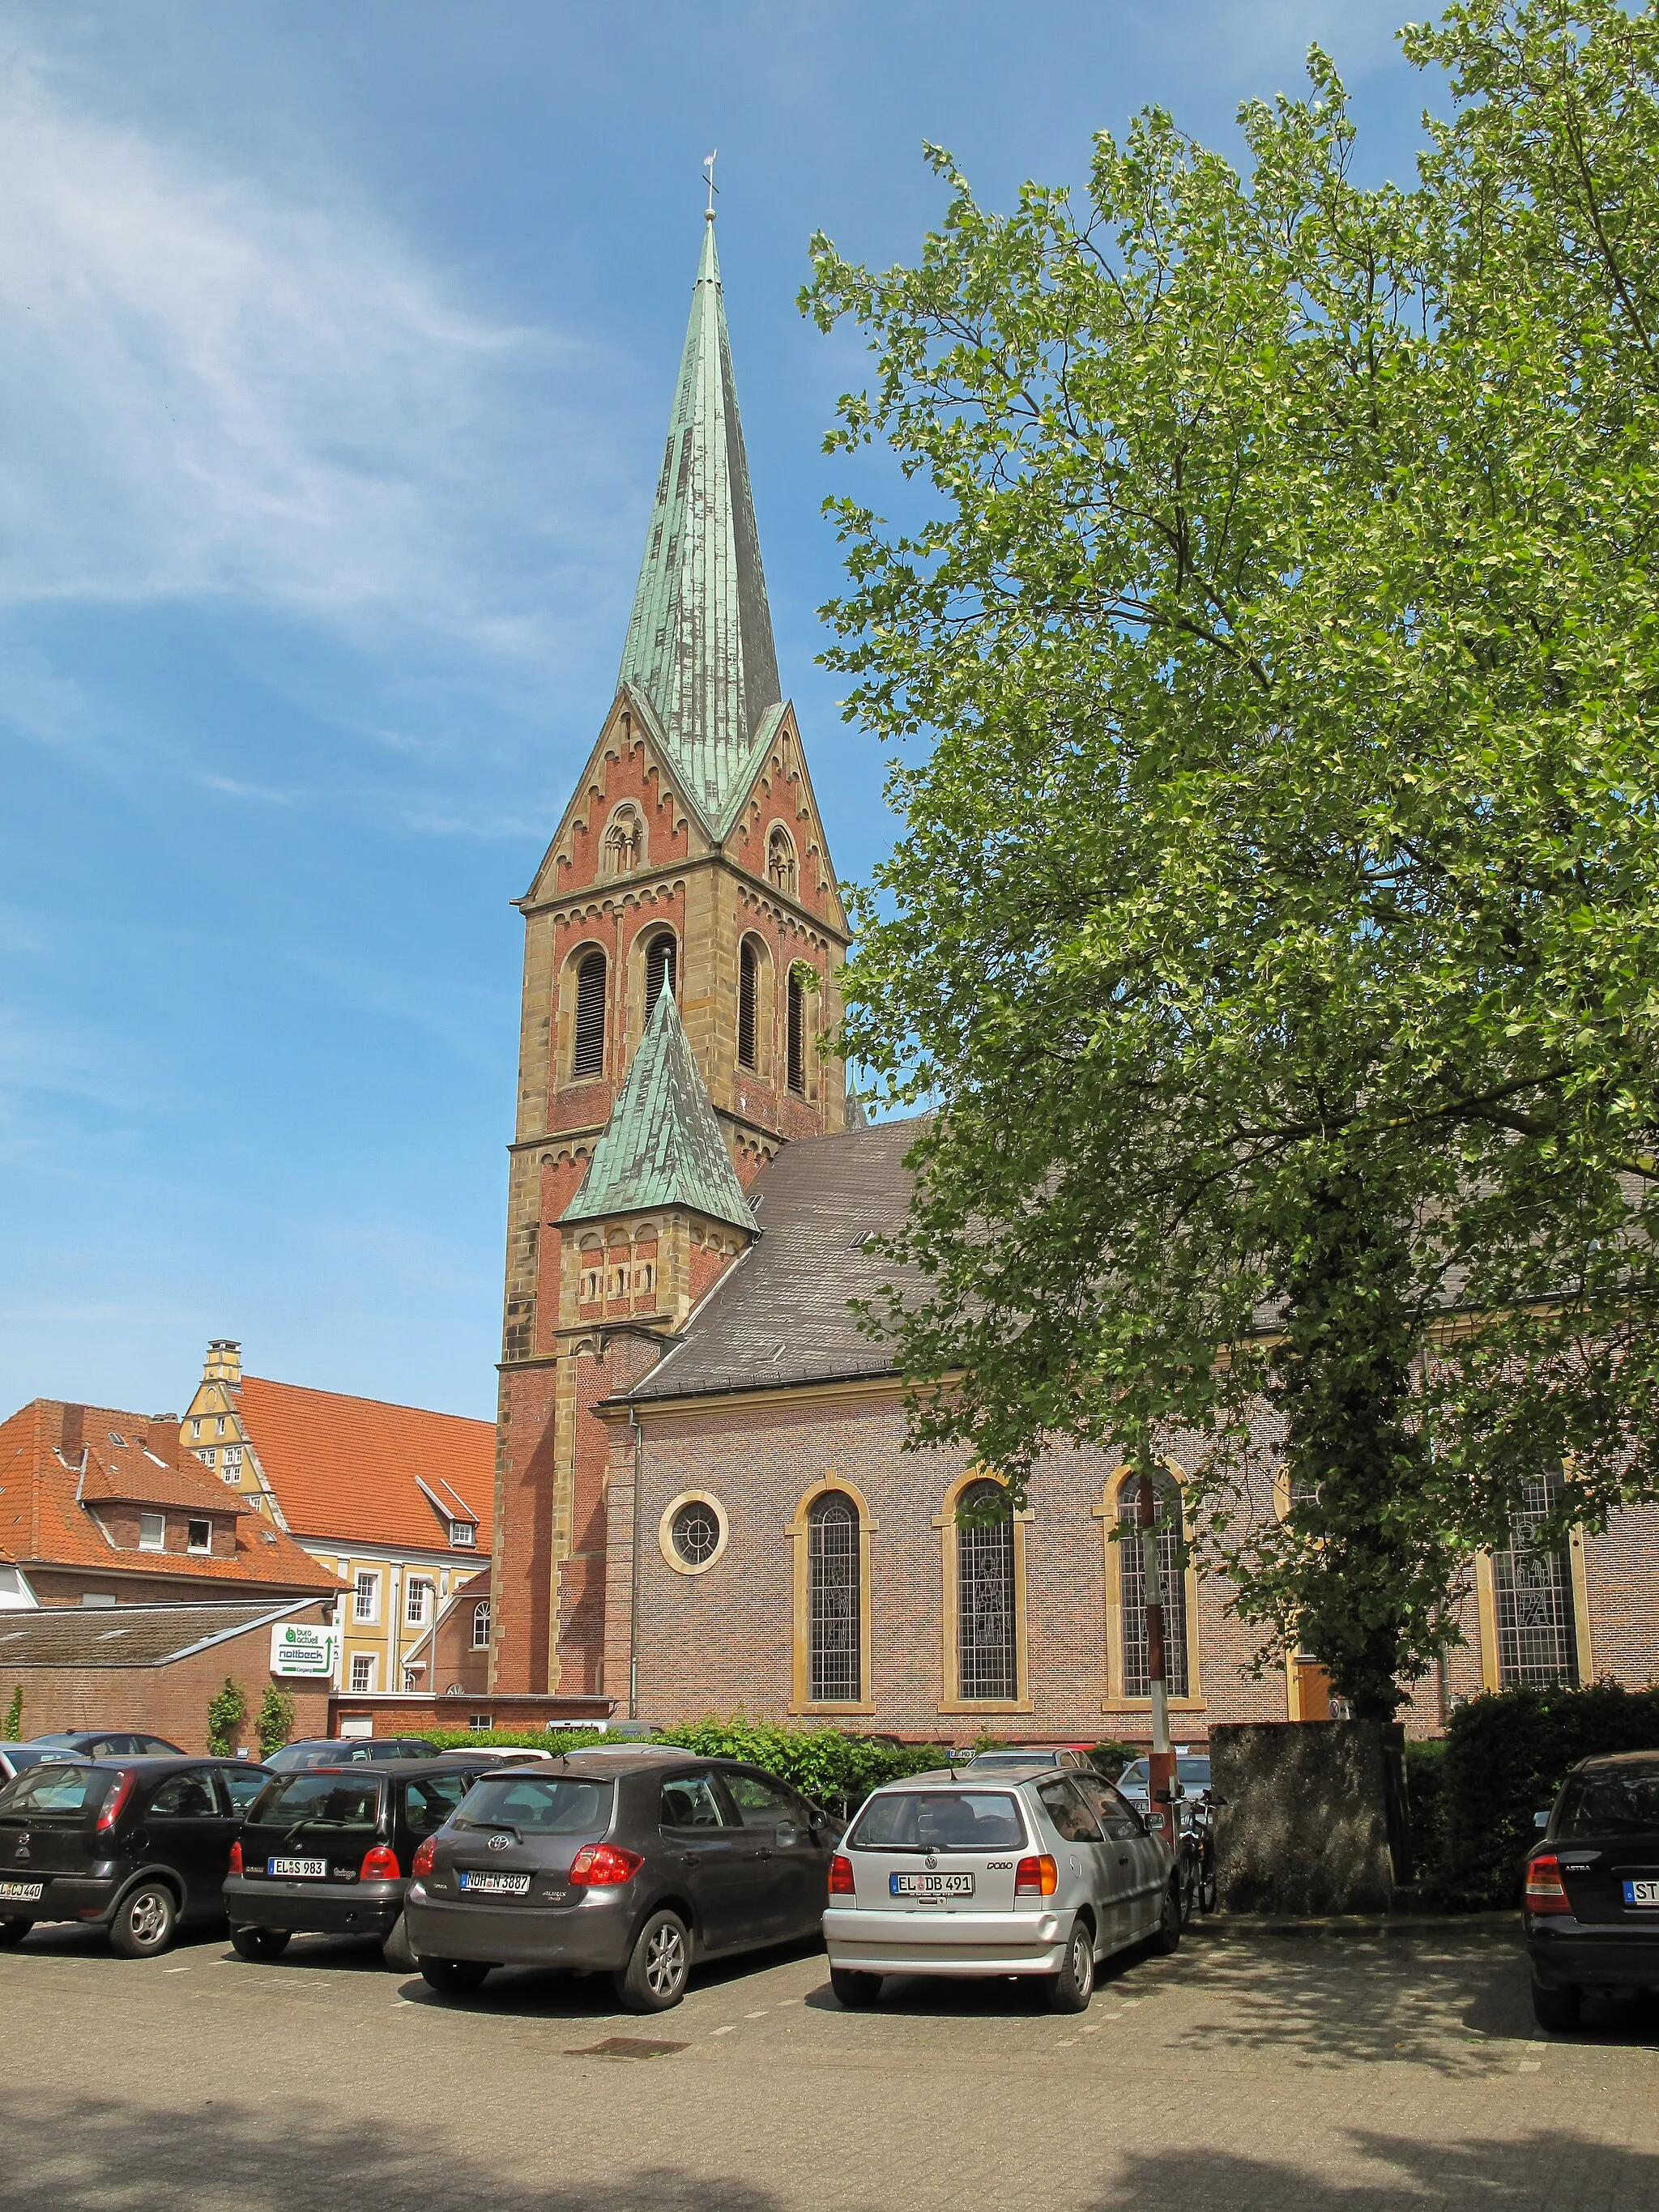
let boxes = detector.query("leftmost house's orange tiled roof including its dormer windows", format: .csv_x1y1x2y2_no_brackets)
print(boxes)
0,1398,336,1606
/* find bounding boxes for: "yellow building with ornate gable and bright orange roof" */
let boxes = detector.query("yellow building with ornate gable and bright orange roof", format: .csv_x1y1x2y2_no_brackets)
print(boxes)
179,1336,496,1694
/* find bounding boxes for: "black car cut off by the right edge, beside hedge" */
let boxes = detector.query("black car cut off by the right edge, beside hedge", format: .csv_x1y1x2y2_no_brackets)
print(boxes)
1522,1752,1659,2028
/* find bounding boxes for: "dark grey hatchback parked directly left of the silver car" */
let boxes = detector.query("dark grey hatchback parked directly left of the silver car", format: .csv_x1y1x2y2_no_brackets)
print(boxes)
405,1750,838,2013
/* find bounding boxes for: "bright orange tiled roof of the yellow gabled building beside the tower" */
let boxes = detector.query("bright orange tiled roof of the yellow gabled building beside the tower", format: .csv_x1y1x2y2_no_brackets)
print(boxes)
232,1376,496,1559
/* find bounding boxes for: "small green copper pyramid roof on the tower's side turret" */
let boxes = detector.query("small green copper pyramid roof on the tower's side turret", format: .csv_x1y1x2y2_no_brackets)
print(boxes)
560,987,757,1232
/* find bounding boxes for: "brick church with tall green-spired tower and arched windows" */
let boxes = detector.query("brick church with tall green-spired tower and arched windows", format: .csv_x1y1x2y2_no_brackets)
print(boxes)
488,215,1659,1743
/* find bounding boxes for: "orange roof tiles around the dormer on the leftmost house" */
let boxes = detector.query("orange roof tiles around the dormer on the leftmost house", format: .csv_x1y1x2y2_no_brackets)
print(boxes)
0,1398,339,1592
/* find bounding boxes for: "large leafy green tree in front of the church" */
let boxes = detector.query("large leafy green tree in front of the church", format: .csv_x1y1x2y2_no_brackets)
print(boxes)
803,0,1659,1715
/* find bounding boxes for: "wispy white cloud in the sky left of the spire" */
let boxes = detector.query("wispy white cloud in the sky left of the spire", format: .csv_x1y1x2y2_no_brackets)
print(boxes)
0,62,615,663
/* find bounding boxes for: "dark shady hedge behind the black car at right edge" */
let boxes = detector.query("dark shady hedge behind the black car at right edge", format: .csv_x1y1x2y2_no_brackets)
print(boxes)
1407,1681,1659,1912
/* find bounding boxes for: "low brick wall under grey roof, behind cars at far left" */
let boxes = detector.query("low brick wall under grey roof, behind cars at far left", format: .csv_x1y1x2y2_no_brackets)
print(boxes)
0,1606,330,1756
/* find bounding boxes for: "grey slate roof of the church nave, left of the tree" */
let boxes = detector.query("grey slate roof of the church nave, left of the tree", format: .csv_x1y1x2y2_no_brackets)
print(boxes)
629,1122,937,1404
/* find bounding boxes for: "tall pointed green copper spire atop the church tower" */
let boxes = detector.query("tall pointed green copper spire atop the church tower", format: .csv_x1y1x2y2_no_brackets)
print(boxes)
620,217,781,825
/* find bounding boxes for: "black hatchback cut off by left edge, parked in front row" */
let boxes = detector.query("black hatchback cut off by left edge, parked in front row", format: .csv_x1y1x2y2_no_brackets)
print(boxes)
0,1754,267,1958
